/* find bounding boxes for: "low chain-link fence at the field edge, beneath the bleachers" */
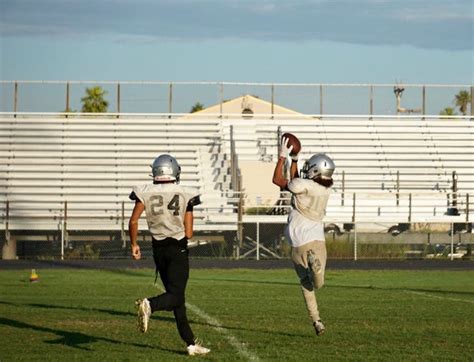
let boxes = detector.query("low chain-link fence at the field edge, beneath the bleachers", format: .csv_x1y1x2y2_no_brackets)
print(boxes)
1,222,474,260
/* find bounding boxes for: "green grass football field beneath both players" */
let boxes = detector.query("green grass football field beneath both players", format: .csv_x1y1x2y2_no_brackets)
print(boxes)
0,269,474,361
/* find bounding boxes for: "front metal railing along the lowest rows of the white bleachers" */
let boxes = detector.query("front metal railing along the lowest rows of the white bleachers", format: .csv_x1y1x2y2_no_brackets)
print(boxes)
0,190,474,231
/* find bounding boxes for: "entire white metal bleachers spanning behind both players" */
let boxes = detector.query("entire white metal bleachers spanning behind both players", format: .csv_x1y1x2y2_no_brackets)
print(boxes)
0,115,474,238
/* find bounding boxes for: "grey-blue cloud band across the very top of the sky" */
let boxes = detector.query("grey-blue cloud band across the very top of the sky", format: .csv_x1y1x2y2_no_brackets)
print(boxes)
0,0,474,50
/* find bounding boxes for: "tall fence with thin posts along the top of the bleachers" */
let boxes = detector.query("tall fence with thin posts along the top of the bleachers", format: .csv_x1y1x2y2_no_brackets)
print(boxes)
0,80,474,116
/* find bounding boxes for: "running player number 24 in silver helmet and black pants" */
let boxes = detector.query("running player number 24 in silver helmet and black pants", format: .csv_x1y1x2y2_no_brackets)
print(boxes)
129,154,210,355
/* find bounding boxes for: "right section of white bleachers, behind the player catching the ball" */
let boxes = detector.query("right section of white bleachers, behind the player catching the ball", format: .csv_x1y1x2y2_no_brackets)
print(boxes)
220,116,474,222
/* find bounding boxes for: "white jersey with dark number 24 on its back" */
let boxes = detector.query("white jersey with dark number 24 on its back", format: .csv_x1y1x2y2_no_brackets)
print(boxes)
130,183,199,240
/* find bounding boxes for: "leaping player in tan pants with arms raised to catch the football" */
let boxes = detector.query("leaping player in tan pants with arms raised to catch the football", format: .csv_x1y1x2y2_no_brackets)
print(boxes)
273,137,336,336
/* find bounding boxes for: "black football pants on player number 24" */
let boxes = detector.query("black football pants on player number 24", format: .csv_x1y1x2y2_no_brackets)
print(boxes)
148,238,194,346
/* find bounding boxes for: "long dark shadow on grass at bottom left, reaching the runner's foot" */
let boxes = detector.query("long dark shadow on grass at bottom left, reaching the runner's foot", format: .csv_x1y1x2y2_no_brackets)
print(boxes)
0,317,183,354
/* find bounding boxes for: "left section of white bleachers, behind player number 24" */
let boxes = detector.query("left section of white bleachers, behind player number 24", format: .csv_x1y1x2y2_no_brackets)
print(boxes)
0,115,236,235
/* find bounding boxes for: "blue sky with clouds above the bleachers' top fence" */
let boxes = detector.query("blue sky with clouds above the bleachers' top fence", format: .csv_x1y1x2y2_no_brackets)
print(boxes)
0,0,474,84
